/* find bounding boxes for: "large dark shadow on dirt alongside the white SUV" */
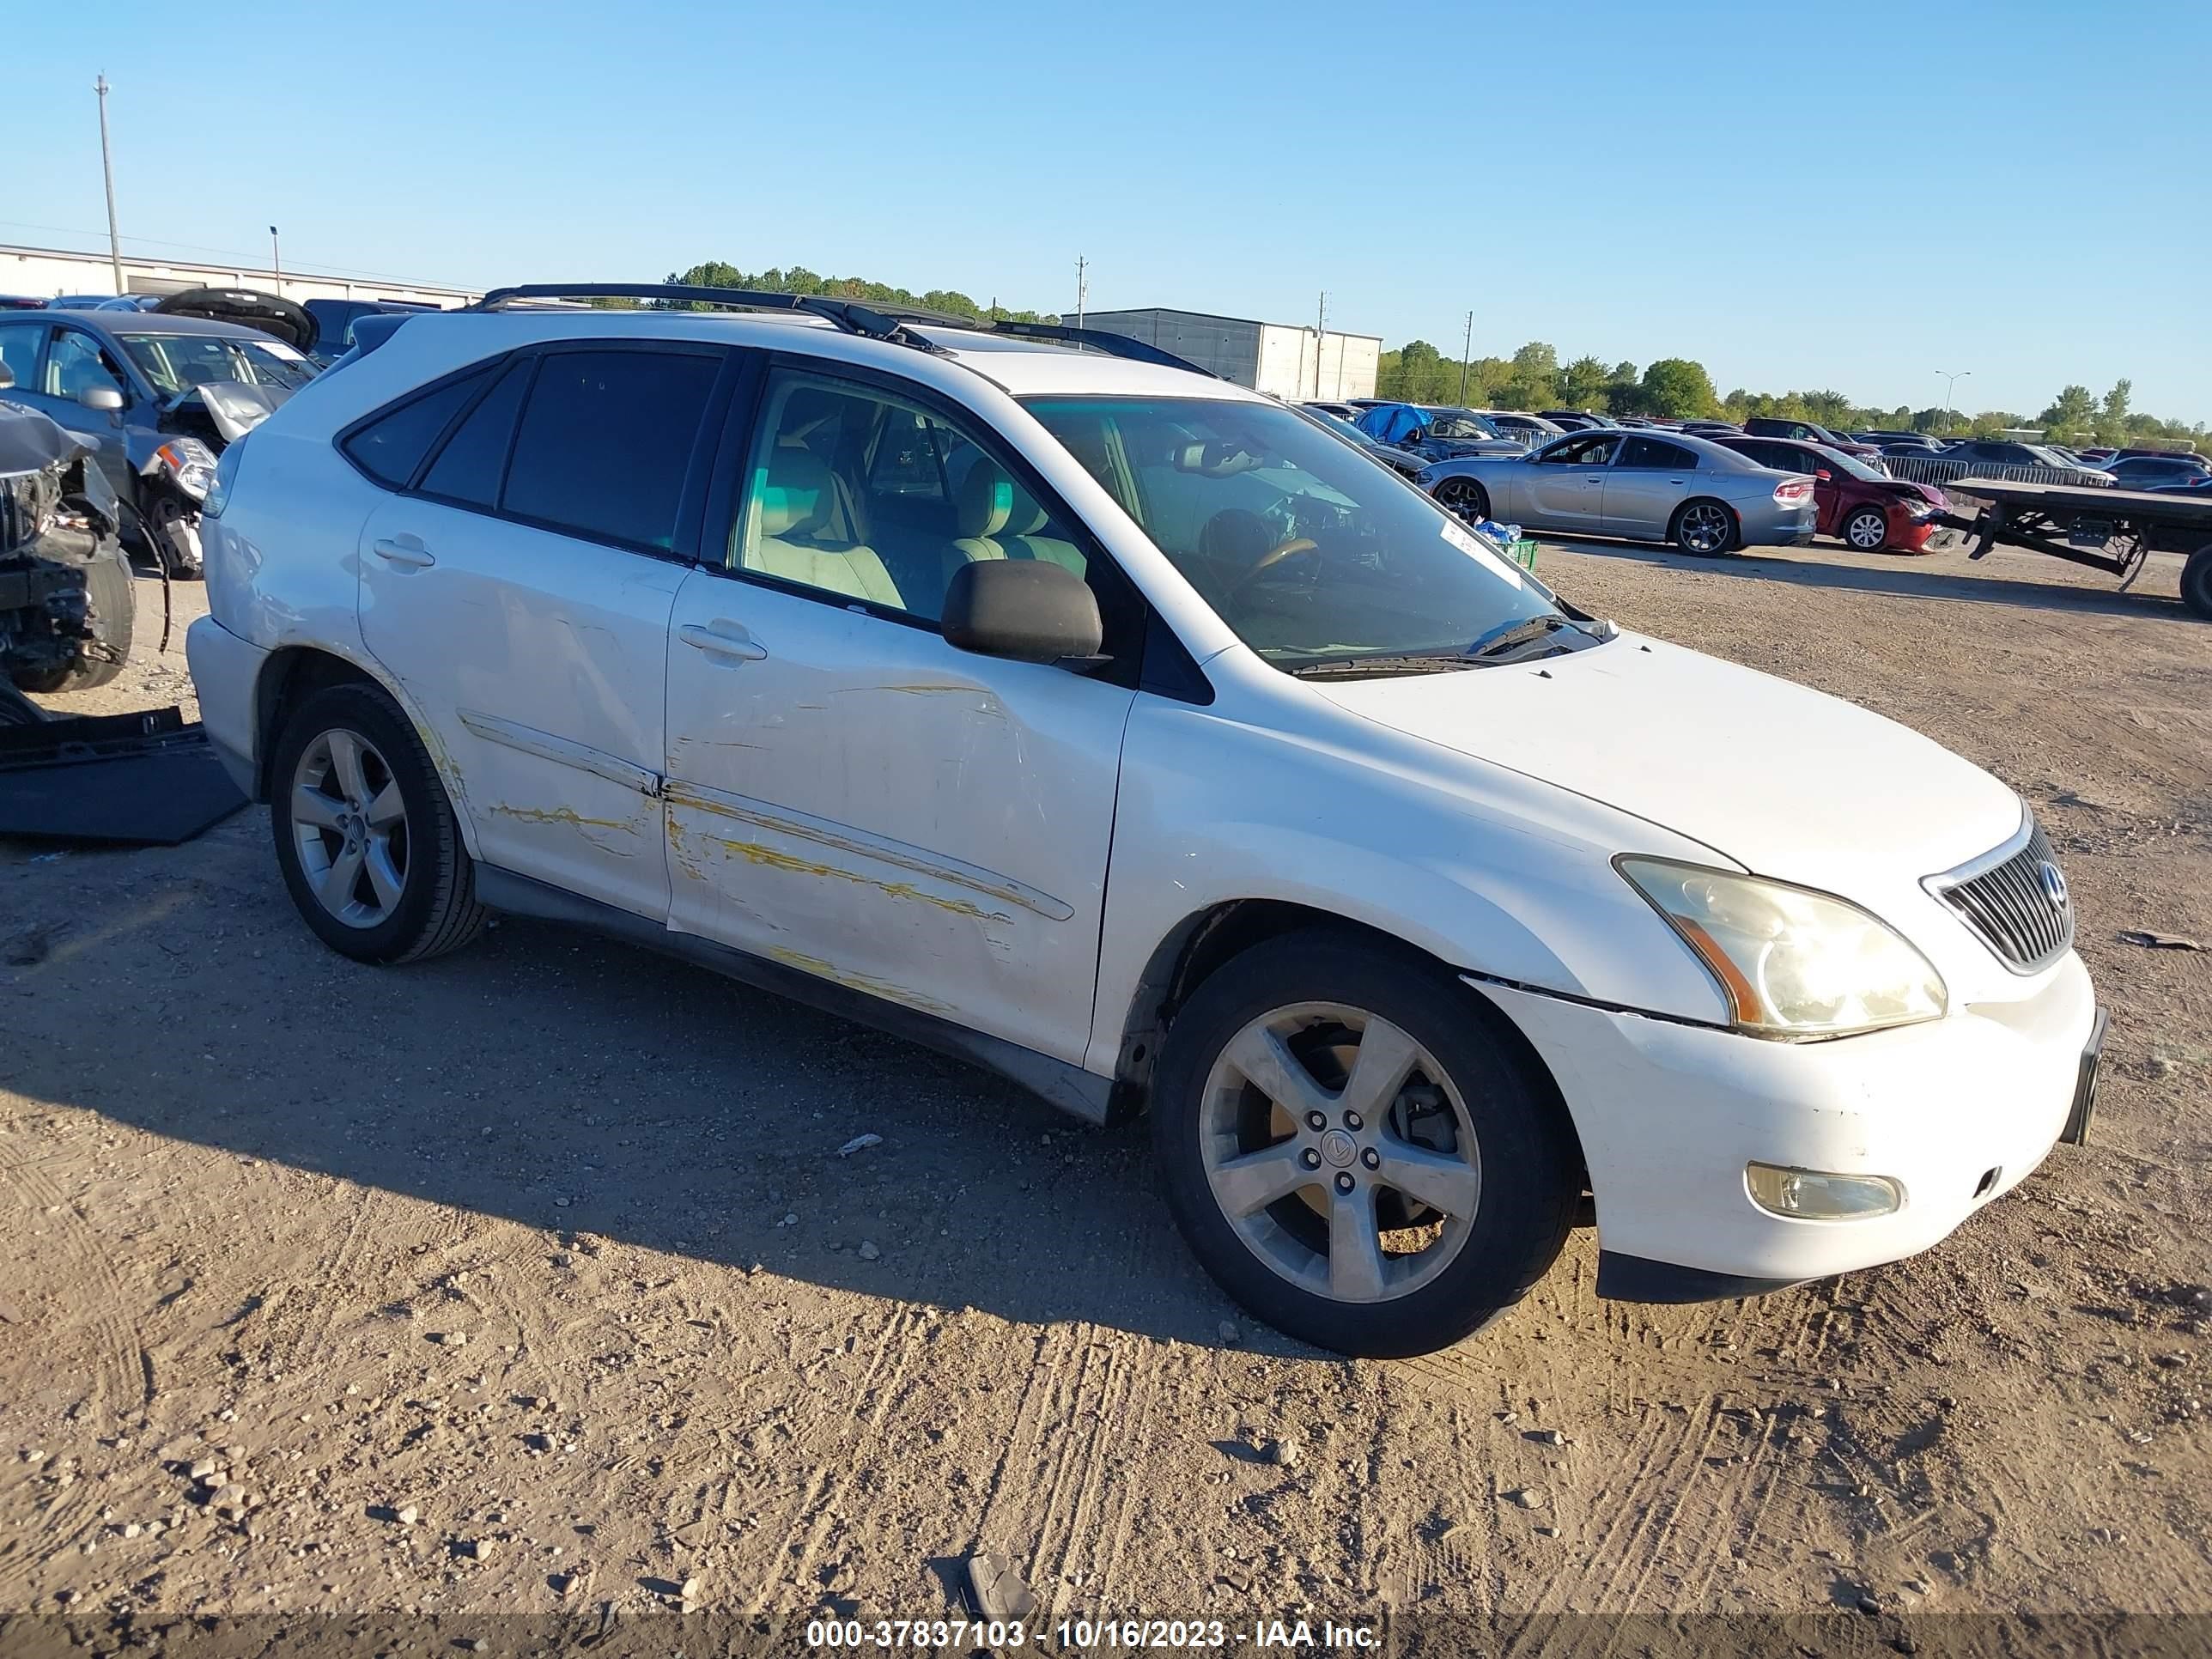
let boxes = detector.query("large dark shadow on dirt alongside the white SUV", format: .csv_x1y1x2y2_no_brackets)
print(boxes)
0,811,1310,1354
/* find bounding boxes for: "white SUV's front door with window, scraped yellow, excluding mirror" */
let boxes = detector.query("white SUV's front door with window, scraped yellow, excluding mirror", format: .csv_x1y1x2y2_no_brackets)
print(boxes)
665,368,1134,1064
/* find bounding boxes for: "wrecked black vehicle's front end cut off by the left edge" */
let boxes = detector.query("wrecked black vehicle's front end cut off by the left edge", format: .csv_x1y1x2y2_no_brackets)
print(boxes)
0,382,137,694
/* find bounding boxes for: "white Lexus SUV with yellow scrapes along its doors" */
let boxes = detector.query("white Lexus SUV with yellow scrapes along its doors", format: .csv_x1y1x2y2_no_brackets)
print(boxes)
191,289,2104,1354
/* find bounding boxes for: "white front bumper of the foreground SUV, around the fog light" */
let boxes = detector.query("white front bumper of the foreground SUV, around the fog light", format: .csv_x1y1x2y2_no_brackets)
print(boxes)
1468,956,2097,1294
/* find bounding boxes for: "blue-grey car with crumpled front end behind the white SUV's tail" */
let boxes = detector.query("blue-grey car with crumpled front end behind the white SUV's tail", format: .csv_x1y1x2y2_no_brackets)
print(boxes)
0,288,316,577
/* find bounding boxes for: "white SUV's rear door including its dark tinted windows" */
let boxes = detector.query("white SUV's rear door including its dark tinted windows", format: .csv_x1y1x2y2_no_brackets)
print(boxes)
354,341,728,921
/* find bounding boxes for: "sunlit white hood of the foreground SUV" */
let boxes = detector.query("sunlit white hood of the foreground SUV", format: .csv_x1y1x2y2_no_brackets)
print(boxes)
1310,633,2020,894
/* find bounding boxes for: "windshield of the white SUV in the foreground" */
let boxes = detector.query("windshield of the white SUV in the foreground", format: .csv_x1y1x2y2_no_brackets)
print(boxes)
1024,398,1564,671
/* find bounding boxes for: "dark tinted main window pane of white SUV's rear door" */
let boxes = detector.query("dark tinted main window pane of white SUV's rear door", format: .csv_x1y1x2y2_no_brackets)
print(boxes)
500,352,721,550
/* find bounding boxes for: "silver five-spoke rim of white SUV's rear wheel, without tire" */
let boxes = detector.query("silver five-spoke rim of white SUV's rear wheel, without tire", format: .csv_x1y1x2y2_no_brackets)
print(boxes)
289,728,410,927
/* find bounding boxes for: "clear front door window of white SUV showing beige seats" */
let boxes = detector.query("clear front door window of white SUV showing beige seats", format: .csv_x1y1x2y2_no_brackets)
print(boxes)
730,372,1106,622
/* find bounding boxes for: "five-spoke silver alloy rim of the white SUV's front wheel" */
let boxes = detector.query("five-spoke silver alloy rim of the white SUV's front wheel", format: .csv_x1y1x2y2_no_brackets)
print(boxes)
1199,1002,1482,1303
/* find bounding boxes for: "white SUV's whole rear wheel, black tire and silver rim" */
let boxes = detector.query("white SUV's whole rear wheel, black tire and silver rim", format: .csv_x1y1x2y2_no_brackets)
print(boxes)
270,686,487,964
